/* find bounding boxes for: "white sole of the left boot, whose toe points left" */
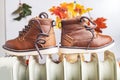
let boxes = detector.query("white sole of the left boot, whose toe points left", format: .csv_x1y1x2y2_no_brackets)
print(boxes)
3,47,58,56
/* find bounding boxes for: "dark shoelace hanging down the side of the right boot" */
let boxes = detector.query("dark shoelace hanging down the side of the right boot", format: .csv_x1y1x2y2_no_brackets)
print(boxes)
80,16,96,49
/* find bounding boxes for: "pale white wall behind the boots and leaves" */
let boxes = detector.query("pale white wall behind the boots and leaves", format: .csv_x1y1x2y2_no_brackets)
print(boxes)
3,0,120,58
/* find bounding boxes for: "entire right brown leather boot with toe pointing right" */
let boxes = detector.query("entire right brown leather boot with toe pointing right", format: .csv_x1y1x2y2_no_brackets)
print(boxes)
60,16,114,54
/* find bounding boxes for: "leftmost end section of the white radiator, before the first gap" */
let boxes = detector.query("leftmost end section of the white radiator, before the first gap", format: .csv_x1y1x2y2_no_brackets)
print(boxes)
0,57,28,80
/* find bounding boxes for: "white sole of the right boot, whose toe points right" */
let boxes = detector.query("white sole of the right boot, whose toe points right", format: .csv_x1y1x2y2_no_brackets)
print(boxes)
59,42,115,54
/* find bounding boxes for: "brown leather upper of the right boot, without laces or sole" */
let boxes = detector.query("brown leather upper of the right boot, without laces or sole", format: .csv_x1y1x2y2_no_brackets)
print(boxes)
61,17,113,48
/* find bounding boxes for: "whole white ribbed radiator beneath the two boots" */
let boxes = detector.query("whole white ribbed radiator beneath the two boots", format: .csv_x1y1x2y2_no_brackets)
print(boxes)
0,51,120,80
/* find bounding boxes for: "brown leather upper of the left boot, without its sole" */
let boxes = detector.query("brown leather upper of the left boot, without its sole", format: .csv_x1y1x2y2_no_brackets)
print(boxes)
4,17,56,50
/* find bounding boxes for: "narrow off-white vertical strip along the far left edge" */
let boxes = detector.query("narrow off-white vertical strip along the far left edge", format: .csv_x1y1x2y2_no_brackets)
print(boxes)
0,0,5,56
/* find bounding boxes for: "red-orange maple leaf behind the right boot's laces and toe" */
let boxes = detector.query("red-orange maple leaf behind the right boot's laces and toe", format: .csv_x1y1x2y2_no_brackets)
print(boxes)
94,17,107,32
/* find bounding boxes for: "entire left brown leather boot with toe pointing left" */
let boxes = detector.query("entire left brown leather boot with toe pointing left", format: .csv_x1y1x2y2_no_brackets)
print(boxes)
3,13,58,56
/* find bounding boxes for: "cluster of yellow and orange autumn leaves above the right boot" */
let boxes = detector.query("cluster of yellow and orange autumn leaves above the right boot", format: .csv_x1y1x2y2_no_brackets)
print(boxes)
49,2,92,28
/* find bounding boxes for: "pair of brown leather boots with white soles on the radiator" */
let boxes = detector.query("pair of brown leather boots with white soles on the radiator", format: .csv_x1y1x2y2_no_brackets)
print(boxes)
3,13,114,57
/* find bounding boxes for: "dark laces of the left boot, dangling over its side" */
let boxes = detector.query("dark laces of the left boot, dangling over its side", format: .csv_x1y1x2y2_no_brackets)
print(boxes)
19,12,50,59
